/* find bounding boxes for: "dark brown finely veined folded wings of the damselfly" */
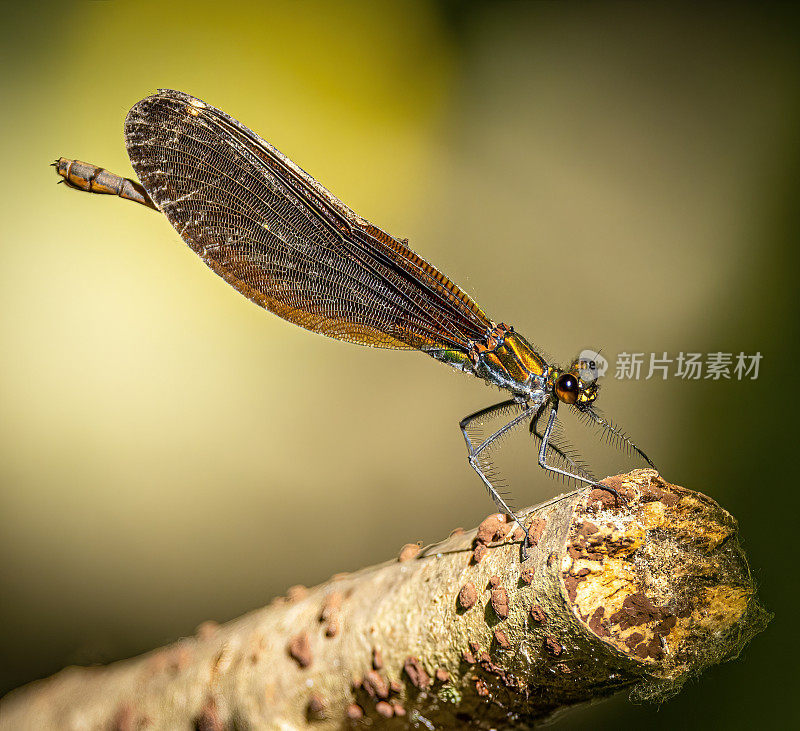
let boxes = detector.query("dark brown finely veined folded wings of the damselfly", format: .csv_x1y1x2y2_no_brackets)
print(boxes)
125,90,493,350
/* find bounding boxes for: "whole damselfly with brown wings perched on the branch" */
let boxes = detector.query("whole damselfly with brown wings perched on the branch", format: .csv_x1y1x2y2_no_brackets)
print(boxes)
53,89,655,536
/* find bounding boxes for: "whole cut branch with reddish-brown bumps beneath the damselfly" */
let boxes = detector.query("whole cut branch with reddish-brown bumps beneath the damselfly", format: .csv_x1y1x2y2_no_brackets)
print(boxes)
0,470,770,731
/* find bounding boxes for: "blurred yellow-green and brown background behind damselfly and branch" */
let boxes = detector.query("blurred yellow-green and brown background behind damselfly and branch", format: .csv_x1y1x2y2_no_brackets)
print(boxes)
0,0,800,729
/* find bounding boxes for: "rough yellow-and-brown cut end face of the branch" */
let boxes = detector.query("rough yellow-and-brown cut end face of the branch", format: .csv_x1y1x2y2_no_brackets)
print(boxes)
561,470,770,701
